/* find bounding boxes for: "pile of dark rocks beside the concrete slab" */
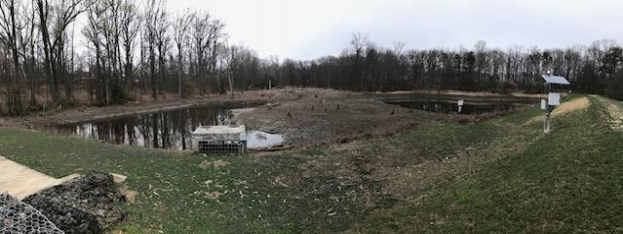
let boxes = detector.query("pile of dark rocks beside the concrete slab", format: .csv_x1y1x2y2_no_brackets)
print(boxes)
24,173,125,233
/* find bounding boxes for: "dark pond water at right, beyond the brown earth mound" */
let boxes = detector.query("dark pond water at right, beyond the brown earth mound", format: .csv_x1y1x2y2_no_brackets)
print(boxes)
385,99,526,115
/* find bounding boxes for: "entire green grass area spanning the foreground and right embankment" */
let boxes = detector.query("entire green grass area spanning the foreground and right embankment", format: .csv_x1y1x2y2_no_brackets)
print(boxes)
0,96,623,233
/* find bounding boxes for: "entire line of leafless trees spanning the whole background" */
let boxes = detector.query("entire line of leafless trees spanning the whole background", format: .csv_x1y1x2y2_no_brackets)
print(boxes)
0,0,623,115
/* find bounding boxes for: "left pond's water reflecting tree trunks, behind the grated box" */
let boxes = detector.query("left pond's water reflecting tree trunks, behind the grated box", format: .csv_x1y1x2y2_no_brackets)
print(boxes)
50,106,284,150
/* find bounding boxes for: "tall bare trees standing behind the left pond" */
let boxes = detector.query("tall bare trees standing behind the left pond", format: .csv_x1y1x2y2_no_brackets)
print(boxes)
0,0,251,115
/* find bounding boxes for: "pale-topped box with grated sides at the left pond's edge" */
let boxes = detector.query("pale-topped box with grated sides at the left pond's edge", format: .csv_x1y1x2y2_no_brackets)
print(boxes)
192,125,247,154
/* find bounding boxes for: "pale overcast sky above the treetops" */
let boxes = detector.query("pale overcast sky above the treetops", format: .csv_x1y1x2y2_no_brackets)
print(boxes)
169,0,623,59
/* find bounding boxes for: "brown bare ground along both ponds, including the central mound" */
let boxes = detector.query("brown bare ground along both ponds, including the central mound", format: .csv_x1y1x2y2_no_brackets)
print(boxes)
0,88,538,149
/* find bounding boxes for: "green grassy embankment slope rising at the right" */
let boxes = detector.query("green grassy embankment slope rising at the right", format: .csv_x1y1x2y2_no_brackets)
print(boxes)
359,95,623,233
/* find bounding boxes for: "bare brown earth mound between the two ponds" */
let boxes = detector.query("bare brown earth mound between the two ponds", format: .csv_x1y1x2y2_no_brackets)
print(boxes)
238,89,418,146
